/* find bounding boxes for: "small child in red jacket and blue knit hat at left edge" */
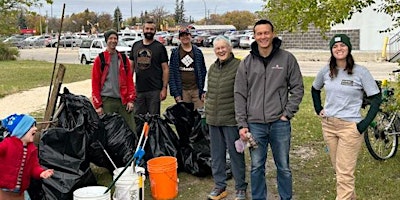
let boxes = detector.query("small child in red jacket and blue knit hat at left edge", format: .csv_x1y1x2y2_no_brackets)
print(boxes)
0,114,54,200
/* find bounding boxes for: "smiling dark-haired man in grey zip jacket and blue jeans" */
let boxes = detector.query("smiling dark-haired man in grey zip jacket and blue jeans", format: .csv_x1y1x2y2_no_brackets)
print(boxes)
234,20,304,200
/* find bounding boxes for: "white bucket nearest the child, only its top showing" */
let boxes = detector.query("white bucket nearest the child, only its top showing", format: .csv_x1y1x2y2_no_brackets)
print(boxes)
73,186,111,200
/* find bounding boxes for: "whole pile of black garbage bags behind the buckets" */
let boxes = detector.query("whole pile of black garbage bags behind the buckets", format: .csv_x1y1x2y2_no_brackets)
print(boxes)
28,88,229,200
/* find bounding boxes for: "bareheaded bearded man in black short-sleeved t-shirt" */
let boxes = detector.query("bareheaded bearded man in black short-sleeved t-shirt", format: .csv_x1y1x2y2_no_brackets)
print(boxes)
129,21,169,115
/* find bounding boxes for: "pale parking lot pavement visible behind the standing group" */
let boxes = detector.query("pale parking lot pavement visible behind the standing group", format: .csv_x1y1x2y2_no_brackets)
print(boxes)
19,46,398,79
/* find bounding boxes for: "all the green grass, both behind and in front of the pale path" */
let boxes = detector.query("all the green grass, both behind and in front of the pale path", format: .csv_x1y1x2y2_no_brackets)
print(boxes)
0,61,400,200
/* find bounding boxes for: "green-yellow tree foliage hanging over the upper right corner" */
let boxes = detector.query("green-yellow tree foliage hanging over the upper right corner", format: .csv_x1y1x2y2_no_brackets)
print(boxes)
258,0,400,33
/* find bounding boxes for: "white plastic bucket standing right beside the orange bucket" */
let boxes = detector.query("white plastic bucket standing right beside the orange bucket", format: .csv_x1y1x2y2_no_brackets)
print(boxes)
113,167,145,200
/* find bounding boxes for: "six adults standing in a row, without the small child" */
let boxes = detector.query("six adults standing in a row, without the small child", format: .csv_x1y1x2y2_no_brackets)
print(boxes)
88,20,380,200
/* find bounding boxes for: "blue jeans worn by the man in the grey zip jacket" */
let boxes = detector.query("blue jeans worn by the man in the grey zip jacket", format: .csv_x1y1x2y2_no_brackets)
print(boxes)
249,120,292,200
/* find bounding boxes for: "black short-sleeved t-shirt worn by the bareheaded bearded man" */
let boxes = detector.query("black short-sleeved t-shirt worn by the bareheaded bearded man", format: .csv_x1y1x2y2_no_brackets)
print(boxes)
129,40,168,92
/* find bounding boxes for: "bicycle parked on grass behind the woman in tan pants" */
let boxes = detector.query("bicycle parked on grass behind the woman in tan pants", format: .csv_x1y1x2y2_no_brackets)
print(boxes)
364,70,400,160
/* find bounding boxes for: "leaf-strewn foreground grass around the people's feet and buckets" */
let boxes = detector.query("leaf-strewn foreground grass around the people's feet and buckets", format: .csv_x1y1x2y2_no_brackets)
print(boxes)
94,77,400,200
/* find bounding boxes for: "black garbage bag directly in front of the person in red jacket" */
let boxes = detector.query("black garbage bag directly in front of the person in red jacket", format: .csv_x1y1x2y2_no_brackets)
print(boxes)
100,113,138,172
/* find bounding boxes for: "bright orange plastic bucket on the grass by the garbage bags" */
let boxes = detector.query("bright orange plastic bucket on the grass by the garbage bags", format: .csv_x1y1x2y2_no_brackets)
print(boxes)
147,156,178,200
